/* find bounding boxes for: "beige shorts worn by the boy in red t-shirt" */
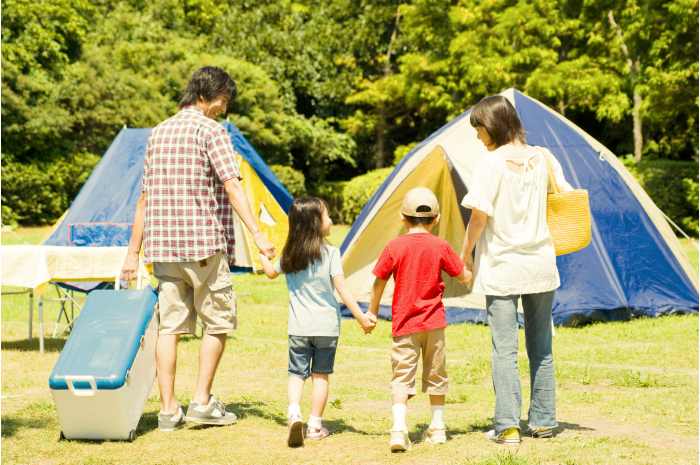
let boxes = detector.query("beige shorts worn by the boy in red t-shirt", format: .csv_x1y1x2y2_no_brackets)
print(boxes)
391,328,448,397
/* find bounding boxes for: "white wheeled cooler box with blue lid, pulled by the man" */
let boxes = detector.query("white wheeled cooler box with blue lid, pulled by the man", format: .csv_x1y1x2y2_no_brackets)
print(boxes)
49,287,158,440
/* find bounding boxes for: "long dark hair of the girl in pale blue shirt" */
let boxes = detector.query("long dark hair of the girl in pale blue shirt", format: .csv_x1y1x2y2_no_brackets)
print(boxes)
280,197,326,273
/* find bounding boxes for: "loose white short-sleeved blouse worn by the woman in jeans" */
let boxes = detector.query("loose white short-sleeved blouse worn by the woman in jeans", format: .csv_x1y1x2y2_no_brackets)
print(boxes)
462,144,572,296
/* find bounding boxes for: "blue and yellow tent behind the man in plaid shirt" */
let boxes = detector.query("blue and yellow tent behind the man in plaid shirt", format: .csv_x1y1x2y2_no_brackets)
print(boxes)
44,121,293,271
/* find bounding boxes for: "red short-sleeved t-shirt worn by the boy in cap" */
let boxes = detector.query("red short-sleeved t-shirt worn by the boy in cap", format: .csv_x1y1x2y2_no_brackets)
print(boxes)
373,233,464,337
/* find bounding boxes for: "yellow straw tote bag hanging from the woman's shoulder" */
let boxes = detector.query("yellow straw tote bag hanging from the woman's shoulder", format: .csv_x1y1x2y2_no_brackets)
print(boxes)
545,154,591,256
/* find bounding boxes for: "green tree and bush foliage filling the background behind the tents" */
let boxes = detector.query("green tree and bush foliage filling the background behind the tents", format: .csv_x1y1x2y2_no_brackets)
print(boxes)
2,0,698,232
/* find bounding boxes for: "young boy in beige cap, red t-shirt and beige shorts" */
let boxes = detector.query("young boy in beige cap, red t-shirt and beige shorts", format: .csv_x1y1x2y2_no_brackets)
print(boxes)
369,187,471,452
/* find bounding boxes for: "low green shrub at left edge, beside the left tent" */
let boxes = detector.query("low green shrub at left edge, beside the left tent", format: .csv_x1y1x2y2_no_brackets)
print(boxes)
2,153,100,225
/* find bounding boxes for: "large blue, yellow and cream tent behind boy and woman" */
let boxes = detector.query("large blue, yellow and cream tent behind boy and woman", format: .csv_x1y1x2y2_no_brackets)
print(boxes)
341,89,698,324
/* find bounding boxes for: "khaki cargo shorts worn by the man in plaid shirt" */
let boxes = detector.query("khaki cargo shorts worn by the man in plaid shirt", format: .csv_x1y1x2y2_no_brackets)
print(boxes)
153,252,237,334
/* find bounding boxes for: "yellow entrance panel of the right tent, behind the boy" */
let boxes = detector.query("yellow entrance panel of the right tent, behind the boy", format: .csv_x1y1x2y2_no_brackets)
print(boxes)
343,146,468,303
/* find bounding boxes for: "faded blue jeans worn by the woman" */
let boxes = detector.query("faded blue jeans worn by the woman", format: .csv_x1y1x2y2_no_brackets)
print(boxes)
486,291,557,433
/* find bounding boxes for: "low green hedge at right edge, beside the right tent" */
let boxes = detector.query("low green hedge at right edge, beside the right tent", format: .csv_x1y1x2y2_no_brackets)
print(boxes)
623,157,698,236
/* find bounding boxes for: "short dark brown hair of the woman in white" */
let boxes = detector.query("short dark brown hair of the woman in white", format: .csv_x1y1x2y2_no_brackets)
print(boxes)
469,95,525,148
